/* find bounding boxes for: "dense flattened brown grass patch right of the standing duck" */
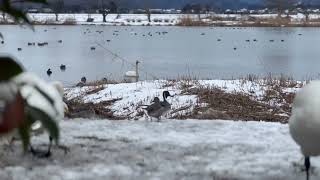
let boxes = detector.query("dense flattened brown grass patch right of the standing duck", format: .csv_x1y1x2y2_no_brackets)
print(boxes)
189,87,287,123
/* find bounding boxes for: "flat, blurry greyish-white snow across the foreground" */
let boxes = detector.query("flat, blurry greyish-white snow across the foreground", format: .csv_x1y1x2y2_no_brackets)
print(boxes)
0,119,320,180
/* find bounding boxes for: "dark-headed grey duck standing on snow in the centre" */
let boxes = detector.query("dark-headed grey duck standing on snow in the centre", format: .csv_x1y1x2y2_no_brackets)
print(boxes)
144,91,173,120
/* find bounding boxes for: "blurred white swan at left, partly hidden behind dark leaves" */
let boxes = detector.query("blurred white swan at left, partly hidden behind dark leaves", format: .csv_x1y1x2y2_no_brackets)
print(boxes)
12,72,65,157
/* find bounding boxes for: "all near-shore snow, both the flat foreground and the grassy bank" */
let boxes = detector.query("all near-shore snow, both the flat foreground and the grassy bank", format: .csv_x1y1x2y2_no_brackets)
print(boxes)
0,79,312,180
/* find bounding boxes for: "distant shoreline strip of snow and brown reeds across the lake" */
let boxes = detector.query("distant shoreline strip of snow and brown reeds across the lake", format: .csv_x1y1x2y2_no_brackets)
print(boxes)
0,13,320,27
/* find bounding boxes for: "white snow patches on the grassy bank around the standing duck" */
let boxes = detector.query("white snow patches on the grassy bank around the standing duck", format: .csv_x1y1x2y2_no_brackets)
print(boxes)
65,80,300,118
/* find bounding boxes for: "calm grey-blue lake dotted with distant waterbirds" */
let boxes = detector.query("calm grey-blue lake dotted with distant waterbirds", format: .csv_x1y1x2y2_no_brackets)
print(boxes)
0,25,320,84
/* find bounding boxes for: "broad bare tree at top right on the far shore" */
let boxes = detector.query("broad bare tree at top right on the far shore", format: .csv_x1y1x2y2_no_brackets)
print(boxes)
265,0,295,17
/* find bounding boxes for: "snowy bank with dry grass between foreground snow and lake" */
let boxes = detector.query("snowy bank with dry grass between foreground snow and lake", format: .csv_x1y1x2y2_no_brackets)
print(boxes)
65,79,303,122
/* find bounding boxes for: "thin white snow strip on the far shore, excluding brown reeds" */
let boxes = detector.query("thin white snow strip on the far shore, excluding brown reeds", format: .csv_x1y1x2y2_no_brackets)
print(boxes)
0,13,320,25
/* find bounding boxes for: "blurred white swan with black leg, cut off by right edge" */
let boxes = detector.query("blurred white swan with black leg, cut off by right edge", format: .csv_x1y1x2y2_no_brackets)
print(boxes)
289,81,320,180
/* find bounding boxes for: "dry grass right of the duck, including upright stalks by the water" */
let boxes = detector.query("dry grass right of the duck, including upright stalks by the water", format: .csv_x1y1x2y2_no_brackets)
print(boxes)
171,74,303,123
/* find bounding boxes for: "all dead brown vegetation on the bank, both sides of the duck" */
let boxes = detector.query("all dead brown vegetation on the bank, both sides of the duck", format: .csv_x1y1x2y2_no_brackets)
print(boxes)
66,74,305,123
